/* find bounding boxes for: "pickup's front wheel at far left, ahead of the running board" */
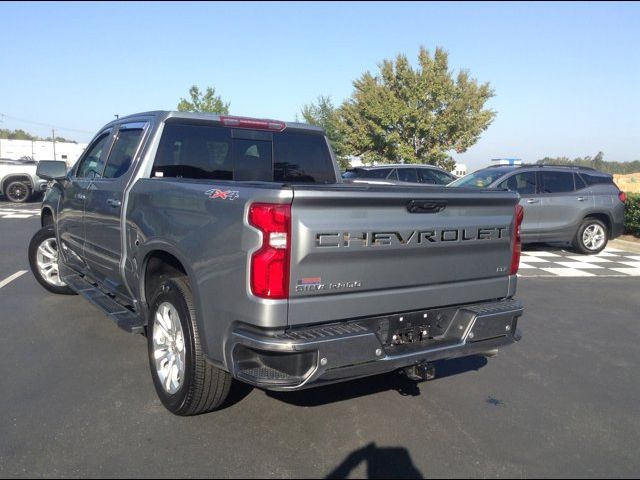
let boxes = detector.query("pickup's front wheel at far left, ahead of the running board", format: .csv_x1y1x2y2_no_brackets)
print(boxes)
29,225,75,295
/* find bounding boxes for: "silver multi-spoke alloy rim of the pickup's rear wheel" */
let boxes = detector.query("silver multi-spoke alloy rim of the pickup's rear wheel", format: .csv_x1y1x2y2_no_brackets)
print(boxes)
153,302,186,395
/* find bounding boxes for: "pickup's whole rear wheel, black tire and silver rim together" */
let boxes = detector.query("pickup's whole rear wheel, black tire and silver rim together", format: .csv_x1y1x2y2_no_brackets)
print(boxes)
147,277,232,416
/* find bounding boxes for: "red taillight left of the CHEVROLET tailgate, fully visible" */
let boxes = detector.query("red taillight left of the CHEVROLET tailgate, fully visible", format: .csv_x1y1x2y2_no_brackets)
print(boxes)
249,203,291,299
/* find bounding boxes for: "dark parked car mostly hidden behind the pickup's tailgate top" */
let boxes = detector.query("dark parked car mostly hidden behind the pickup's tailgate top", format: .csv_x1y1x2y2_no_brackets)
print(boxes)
342,164,456,185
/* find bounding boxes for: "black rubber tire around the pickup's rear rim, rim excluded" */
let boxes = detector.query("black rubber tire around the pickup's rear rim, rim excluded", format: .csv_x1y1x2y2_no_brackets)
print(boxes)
147,276,232,416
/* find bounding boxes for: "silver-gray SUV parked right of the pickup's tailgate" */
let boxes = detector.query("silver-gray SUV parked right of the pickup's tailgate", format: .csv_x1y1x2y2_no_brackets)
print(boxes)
449,165,626,254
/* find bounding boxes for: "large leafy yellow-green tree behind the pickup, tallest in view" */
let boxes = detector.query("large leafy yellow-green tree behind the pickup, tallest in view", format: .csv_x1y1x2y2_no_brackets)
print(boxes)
340,47,496,170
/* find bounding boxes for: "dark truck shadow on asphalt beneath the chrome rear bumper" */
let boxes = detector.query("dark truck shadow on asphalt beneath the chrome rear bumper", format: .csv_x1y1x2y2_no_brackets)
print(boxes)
266,356,487,407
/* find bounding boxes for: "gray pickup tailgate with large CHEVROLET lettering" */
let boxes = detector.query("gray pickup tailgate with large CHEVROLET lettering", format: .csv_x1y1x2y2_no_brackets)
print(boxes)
288,185,518,325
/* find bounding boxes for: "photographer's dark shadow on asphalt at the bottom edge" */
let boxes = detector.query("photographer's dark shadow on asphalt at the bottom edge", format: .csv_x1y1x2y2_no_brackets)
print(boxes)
326,443,424,478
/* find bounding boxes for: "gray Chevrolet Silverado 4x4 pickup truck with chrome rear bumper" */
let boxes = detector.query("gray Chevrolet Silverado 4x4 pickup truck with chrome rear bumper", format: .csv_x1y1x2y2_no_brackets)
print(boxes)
29,112,523,415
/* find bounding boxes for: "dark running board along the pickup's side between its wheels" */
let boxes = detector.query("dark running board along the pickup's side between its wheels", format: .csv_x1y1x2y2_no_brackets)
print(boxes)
61,274,144,333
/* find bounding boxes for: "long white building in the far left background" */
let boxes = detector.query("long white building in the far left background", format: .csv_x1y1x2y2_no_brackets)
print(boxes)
0,138,87,166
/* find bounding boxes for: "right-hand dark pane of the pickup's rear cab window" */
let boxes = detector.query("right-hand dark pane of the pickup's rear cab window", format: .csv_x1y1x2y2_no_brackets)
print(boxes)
273,132,336,183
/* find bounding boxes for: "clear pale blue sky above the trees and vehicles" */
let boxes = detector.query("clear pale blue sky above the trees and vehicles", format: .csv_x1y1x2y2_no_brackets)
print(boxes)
0,2,640,169
